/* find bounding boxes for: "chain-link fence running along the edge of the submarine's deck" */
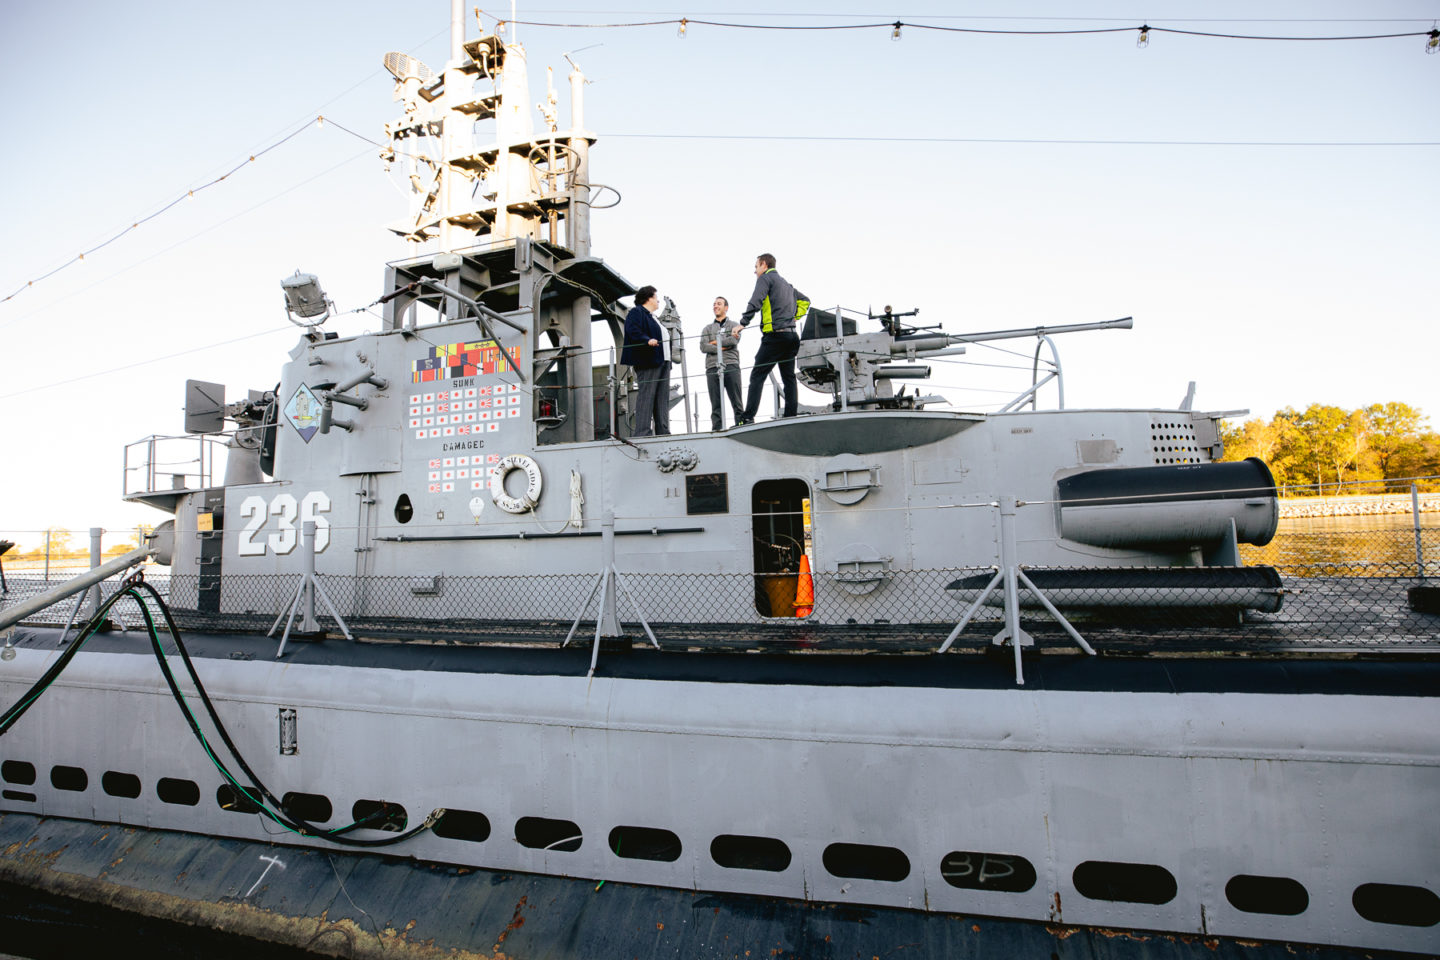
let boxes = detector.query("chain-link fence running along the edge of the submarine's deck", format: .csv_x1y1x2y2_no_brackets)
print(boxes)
0,515,1440,653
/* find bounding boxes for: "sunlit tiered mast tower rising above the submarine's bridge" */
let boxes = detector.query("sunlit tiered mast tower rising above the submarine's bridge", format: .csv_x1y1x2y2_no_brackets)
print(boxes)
382,0,622,442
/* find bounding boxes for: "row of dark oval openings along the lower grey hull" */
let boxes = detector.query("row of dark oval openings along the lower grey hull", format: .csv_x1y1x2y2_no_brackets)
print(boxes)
0,760,1440,927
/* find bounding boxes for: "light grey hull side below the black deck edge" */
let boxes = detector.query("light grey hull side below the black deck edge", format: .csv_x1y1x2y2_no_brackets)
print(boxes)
0,649,1440,950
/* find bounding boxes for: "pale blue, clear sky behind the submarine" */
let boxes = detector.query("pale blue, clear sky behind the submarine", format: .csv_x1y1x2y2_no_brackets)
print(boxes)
0,0,1440,544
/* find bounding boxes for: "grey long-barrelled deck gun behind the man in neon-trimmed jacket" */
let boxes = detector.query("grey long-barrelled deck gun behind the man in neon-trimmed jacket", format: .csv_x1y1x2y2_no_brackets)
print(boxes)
795,307,1133,410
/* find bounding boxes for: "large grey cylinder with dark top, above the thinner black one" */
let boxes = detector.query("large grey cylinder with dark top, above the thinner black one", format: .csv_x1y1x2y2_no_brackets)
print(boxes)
1057,458,1280,548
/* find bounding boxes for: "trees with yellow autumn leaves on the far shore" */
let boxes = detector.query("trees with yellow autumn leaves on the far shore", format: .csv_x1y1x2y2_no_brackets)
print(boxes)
1221,402,1440,497
